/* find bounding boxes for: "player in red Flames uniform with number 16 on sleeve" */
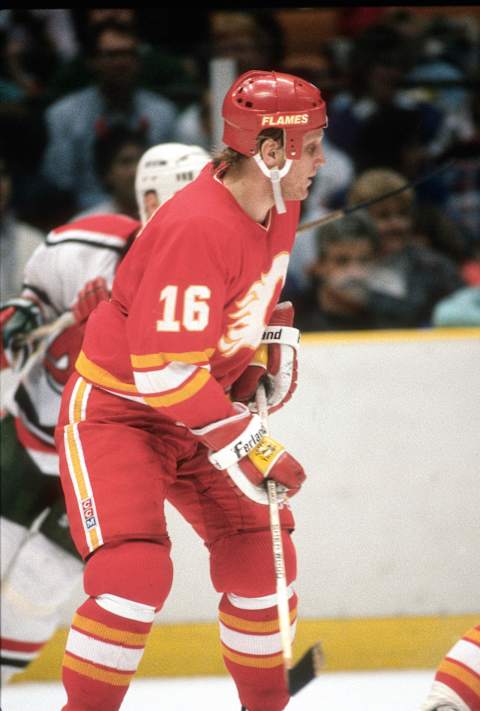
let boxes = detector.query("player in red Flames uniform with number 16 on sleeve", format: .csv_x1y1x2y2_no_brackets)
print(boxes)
55,71,326,711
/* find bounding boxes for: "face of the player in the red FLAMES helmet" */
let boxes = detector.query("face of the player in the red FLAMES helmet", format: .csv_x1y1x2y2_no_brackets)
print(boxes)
282,128,325,200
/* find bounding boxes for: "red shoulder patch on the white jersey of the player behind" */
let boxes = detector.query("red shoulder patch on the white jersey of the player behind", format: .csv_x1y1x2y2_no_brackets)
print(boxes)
46,213,141,244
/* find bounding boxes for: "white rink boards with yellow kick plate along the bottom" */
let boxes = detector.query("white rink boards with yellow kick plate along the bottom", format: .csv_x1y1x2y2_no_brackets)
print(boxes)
8,329,480,679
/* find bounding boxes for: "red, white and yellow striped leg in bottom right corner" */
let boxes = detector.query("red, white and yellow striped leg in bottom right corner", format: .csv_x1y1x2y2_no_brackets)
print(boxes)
421,624,480,711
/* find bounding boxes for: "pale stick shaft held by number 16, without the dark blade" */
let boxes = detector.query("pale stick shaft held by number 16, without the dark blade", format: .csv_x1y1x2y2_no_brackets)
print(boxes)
257,384,292,671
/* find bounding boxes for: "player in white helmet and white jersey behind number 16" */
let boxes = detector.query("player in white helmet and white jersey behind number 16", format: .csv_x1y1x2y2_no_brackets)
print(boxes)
0,143,209,683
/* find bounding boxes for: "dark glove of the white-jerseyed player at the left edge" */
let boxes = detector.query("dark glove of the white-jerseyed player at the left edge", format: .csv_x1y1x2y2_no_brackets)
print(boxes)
0,297,42,369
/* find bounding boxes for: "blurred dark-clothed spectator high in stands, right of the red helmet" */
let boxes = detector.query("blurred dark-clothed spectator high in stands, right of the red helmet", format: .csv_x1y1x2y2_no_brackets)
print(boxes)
329,25,442,177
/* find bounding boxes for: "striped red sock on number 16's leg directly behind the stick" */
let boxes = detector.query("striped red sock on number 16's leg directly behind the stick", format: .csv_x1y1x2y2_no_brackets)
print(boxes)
219,588,297,711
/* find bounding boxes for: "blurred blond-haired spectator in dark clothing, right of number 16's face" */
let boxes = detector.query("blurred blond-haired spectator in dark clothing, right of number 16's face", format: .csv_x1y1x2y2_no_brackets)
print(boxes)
348,169,464,328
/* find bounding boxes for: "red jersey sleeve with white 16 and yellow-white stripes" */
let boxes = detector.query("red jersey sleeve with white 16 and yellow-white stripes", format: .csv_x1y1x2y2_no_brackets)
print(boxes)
127,220,233,427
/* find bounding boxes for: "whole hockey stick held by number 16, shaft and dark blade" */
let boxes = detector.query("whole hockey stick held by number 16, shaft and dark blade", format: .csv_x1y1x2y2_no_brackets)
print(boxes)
256,383,324,696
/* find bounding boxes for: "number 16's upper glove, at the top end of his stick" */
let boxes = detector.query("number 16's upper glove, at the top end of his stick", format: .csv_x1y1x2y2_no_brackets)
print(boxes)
230,301,300,414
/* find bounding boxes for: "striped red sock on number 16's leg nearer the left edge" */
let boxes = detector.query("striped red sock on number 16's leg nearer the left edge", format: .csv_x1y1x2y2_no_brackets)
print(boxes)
62,595,155,711
